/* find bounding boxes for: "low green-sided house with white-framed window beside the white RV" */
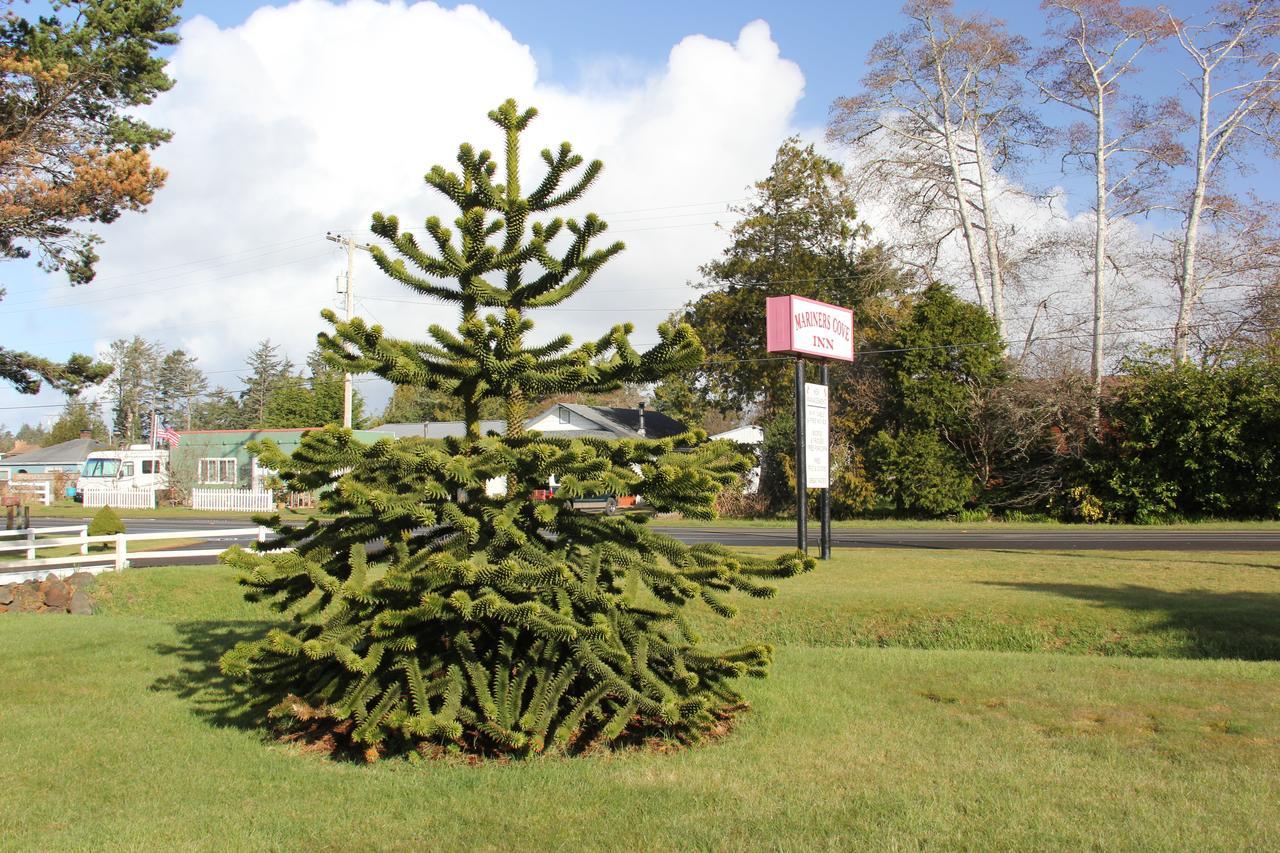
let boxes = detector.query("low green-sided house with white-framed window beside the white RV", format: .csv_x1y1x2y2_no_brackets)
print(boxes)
169,428,394,491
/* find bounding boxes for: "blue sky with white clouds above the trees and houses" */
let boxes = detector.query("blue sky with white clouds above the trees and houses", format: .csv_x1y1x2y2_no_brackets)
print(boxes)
0,0,1249,428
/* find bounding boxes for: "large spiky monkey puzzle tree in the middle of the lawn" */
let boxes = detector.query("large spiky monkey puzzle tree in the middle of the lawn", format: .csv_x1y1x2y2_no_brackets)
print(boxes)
223,101,813,756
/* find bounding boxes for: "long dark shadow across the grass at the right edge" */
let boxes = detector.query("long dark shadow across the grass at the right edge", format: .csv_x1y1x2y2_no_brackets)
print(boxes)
982,580,1280,661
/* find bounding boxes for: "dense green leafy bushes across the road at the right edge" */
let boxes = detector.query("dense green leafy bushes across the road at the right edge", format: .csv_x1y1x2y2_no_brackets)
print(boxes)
1089,350,1280,521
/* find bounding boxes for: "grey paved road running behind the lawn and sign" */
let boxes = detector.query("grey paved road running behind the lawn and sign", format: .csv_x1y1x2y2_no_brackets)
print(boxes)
32,517,1280,551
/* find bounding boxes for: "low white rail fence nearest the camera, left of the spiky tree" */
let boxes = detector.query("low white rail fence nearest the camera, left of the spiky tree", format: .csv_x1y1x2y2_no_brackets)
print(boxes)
0,524,280,584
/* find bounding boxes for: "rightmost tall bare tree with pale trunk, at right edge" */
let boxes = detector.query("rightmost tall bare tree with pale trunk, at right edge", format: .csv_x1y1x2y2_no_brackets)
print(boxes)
1162,0,1280,361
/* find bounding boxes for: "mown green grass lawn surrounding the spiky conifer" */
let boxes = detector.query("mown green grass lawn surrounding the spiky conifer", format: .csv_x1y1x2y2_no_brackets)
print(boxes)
0,551,1280,849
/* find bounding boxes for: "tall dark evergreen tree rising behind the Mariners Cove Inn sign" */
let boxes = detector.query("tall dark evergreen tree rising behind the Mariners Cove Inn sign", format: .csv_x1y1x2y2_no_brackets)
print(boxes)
655,138,909,510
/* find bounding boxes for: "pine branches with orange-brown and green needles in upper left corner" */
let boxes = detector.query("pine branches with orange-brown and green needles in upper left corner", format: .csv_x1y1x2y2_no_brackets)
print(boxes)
0,0,180,393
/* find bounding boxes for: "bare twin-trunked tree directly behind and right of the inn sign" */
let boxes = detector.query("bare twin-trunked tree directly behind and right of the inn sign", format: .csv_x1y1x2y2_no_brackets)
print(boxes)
828,0,1044,339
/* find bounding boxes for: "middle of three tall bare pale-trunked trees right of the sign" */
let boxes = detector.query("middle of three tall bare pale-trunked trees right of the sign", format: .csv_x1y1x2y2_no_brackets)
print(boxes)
1032,0,1184,424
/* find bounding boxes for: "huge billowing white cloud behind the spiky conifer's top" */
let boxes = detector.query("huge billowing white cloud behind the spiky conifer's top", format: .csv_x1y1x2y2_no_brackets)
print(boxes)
74,0,804,404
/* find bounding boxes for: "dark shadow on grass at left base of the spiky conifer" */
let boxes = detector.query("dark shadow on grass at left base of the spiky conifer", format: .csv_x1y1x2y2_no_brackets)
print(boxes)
151,621,275,733
